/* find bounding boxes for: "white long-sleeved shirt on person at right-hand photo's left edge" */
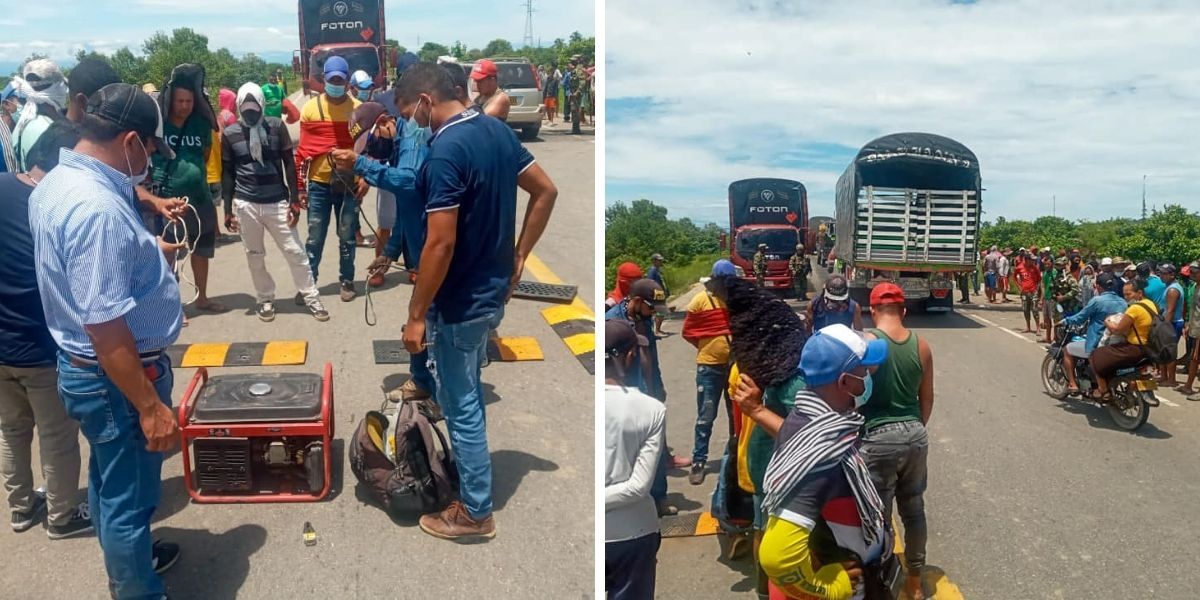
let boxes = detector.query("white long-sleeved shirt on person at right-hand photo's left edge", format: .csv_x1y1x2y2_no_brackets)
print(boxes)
604,385,667,542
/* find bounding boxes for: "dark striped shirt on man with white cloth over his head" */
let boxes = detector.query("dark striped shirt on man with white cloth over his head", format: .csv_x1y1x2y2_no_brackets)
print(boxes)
221,116,292,205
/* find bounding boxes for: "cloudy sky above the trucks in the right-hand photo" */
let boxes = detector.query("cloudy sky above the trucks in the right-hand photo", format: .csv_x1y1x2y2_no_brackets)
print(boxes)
605,0,1200,226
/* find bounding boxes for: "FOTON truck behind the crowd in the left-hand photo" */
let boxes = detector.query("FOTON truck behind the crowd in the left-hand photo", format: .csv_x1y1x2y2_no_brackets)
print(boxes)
292,0,398,95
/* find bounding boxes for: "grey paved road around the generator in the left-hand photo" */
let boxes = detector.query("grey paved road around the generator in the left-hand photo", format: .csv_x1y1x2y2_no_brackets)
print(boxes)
0,120,595,600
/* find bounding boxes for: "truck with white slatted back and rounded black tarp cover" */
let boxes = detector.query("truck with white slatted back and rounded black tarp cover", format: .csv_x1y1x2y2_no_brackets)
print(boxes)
834,132,983,312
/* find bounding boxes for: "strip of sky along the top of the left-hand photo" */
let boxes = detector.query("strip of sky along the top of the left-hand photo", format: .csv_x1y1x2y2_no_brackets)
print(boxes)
0,0,595,73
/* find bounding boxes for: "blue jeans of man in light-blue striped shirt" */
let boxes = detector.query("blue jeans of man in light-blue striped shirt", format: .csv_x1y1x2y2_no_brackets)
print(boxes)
59,353,174,600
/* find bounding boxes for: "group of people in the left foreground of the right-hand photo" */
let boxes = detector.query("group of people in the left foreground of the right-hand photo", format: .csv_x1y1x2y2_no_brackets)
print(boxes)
605,259,934,599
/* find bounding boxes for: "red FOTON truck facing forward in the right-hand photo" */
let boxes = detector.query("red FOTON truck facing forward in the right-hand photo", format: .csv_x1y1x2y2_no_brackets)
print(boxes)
728,178,809,294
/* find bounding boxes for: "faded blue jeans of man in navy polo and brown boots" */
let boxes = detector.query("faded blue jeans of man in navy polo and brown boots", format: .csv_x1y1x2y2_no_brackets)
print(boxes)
425,311,498,520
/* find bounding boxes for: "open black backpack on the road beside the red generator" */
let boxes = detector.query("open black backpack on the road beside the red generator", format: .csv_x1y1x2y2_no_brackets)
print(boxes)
349,402,458,517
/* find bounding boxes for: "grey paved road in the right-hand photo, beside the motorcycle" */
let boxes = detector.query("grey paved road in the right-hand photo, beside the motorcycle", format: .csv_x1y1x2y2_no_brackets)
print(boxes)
658,288,1200,600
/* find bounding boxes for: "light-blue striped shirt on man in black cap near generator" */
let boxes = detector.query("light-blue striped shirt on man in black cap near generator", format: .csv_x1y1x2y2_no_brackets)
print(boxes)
29,149,184,358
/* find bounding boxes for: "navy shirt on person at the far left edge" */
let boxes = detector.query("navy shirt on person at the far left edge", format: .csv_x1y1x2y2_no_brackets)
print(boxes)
0,175,58,367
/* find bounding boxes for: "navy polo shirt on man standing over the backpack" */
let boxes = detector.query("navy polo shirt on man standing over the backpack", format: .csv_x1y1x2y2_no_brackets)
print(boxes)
416,110,534,323
